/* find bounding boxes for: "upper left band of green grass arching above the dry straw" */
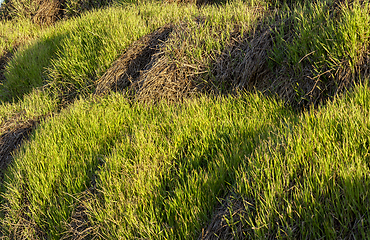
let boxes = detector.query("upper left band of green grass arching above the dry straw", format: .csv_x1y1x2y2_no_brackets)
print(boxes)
0,2,261,100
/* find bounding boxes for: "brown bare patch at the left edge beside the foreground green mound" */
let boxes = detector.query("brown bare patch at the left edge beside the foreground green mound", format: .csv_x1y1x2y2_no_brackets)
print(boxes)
0,118,39,182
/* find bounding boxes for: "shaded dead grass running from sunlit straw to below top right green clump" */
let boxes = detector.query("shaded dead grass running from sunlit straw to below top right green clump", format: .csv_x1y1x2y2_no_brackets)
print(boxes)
212,19,336,108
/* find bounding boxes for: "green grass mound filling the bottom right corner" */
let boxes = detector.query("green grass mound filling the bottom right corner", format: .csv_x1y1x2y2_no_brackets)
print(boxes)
233,83,370,239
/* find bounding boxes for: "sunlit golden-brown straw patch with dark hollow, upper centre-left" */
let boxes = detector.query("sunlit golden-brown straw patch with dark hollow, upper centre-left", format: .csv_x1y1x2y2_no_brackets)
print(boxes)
95,24,211,102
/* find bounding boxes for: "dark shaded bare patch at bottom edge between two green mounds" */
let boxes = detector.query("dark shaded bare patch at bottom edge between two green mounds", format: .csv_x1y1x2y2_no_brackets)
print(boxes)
198,196,246,240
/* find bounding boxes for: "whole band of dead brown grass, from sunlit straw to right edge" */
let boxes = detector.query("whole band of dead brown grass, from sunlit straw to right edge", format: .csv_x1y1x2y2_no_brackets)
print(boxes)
96,4,370,108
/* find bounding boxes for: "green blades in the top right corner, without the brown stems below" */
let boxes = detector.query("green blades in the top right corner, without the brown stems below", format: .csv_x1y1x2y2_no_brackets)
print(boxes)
271,1,370,76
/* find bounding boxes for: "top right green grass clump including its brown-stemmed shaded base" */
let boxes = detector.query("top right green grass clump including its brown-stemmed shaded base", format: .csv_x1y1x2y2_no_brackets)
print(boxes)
270,1,370,102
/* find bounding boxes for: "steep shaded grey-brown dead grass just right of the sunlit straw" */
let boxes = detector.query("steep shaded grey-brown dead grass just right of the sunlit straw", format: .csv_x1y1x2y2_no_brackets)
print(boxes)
212,25,273,94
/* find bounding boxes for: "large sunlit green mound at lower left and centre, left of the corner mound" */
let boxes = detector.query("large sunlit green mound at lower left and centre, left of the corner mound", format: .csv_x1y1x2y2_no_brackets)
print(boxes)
3,91,289,239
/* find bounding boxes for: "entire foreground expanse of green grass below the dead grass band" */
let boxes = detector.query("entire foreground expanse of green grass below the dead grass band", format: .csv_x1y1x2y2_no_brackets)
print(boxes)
2,86,370,239
